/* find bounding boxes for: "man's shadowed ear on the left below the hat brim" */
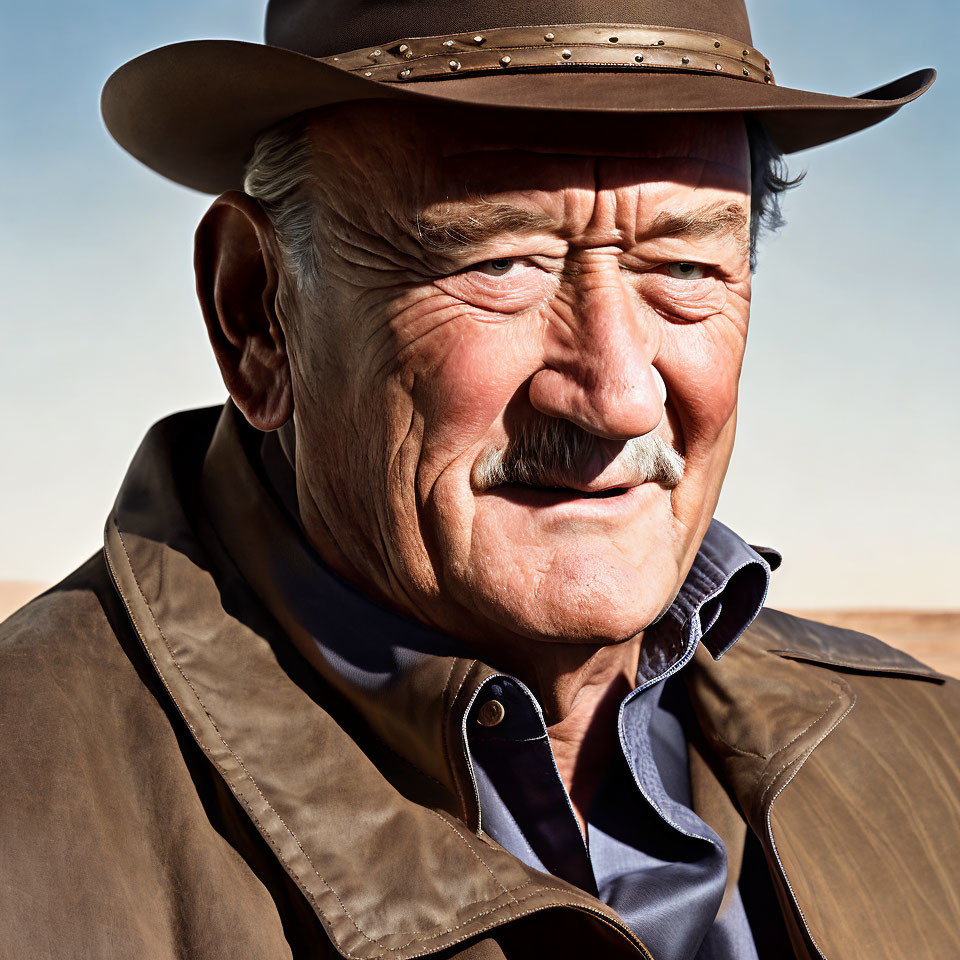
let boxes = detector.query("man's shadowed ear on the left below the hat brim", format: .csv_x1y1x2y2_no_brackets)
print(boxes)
193,190,293,430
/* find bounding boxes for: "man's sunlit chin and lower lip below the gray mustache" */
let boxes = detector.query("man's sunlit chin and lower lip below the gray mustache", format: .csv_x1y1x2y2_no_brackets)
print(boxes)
435,484,680,646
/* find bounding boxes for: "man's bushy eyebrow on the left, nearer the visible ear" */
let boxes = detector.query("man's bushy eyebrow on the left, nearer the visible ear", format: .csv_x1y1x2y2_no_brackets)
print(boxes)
416,203,559,257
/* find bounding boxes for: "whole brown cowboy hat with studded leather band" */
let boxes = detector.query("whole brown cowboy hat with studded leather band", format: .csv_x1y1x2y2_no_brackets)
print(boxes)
101,0,936,193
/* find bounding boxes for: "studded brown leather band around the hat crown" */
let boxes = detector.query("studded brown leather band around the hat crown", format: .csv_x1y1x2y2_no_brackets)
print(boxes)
322,23,774,83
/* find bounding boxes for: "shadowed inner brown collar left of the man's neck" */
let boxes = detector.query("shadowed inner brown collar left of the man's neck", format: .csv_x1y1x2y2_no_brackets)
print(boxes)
201,403,480,808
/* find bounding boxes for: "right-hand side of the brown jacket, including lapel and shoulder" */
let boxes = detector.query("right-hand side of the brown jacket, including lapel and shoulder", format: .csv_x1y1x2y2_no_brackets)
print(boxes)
687,610,960,960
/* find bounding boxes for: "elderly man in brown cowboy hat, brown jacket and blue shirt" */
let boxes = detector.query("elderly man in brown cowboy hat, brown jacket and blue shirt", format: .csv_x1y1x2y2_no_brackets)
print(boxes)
0,0,960,960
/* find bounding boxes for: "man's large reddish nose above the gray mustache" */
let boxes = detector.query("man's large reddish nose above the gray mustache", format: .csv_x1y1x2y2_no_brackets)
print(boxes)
529,270,666,440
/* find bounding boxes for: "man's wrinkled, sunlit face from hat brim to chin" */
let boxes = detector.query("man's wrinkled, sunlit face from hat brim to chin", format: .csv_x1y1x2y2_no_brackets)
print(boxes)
286,104,750,644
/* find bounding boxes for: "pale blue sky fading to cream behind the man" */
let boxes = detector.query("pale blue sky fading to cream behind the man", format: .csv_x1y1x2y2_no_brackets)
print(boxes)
0,0,960,607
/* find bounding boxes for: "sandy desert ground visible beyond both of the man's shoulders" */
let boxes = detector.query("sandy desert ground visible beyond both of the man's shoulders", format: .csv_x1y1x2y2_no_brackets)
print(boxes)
0,580,960,678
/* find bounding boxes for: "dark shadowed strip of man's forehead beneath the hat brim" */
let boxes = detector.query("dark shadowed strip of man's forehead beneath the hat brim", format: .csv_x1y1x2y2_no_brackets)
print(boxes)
304,101,750,212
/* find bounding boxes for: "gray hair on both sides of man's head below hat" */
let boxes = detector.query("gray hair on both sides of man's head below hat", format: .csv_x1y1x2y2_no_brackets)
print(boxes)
243,115,803,297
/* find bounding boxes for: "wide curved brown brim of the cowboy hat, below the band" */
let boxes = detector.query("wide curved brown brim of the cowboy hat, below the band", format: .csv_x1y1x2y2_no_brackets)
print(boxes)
101,40,936,193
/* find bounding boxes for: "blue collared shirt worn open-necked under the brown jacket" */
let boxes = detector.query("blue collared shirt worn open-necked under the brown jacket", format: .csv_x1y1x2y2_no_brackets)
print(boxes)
463,521,770,960
